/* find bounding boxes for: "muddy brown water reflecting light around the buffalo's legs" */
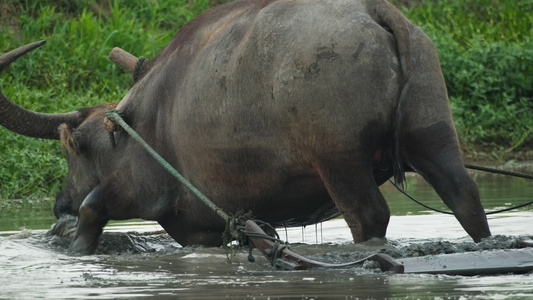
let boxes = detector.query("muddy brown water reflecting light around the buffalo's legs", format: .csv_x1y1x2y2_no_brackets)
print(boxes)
0,166,533,299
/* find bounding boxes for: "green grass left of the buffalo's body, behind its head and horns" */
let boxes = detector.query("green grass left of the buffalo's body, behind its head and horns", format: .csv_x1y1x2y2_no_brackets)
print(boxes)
0,0,227,199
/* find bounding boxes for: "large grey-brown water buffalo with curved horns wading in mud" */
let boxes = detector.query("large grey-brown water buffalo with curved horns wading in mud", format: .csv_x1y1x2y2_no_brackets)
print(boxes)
0,0,490,253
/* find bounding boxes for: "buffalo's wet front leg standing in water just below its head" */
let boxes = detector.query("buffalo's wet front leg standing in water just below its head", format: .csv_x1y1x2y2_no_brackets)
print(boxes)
70,185,109,255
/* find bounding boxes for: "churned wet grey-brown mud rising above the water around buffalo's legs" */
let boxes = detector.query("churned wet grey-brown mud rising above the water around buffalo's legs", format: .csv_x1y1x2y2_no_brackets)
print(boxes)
44,216,533,262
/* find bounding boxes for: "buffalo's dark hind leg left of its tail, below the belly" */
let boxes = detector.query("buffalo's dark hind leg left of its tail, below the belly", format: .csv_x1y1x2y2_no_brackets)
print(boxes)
320,160,390,243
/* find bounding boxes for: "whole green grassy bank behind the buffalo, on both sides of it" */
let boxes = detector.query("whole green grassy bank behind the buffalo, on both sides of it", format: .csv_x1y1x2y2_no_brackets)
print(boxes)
0,0,533,199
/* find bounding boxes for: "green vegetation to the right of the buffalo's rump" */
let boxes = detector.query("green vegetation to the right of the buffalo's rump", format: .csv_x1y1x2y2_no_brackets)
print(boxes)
404,0,533,151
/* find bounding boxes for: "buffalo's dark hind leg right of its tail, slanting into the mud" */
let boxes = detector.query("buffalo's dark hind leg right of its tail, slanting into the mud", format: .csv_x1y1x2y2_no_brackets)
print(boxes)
404,122,491,242
